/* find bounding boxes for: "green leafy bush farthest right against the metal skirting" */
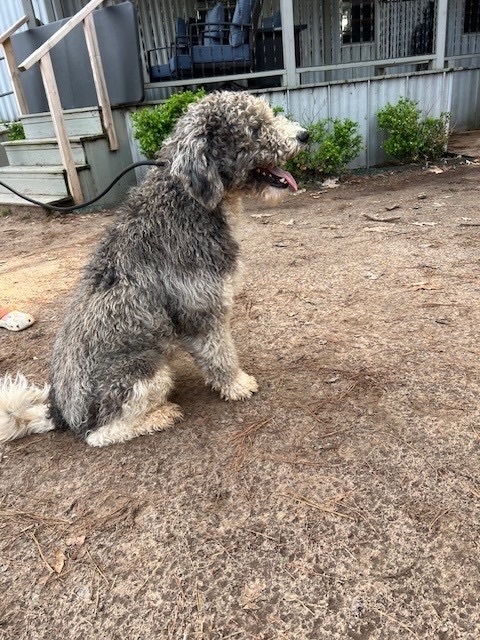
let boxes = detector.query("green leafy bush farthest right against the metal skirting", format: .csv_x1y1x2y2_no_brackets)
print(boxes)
377,98,449,163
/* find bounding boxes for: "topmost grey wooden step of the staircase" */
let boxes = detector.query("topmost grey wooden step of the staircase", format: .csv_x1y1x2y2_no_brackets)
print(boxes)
20,107,104,140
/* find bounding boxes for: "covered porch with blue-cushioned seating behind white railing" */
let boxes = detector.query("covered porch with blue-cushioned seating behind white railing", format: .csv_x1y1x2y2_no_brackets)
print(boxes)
127,0,480,100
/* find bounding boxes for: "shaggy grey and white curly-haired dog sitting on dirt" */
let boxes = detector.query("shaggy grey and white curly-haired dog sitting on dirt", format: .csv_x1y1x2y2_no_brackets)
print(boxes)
0,92,308,447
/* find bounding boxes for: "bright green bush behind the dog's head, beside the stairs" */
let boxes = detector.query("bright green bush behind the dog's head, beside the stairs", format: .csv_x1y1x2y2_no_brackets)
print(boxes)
132,89,205,160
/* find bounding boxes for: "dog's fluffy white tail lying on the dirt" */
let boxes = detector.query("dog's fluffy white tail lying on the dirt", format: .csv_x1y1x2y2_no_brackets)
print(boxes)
0,373,55,443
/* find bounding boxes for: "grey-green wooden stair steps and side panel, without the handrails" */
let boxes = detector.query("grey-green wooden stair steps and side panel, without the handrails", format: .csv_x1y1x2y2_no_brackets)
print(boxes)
0,107,135,208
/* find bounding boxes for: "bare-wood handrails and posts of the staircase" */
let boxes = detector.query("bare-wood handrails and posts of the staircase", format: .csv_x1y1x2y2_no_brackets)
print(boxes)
1,0,119,204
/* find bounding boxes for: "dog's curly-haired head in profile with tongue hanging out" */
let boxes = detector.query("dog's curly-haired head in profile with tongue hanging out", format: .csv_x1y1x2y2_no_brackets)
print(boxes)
164,91,308,209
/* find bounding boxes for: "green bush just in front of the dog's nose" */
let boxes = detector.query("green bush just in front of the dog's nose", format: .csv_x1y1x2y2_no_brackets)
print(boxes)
287,118,362,180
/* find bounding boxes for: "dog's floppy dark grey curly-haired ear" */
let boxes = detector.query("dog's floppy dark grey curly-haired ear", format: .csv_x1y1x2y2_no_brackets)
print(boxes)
171,135,224,210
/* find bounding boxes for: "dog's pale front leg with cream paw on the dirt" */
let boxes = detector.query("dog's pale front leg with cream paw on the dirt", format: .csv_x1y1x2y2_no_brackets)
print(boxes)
184,321,258,400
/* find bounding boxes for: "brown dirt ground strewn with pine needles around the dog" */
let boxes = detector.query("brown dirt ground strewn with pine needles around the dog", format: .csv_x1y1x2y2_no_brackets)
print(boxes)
0,164,480,640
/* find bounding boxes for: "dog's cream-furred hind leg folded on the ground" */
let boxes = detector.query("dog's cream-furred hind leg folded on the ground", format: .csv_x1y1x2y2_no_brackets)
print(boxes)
85,367,182,447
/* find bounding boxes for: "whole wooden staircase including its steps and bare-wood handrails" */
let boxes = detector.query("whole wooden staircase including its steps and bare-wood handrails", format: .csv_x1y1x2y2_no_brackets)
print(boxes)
0,0,135,208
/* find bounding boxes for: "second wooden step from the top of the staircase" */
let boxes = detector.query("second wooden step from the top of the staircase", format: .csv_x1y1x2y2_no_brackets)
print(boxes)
2,137,87,167
